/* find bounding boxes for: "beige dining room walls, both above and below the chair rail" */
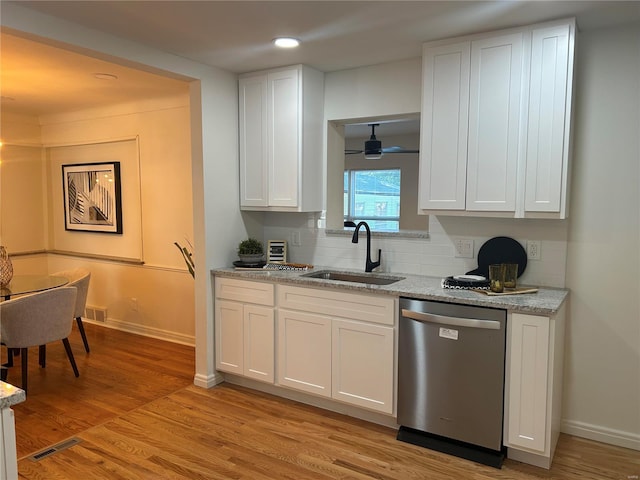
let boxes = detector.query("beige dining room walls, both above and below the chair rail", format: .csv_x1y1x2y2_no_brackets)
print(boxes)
1,96,195,344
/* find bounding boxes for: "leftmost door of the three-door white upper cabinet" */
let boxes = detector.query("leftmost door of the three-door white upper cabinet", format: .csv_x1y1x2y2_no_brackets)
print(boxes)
419,42,471,210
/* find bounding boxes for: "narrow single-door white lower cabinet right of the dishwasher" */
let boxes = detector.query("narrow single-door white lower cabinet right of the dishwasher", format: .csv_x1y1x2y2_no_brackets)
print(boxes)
504,308,564,468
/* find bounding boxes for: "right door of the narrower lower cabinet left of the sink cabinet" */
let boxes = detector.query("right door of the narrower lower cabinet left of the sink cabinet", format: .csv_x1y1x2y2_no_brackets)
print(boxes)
244,305,276,383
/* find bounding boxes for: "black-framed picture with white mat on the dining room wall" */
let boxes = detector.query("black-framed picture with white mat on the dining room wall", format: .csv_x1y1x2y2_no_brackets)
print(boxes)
62,162,122,233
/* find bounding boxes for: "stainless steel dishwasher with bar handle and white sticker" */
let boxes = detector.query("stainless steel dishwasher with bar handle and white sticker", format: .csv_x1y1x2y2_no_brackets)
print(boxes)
398,298,507,468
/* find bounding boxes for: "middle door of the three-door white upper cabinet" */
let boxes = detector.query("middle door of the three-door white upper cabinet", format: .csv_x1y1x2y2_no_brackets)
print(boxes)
466,33,523,211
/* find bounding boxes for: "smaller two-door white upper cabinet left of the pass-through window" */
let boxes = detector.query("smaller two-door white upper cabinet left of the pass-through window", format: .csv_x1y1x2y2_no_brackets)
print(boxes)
239,65,324,212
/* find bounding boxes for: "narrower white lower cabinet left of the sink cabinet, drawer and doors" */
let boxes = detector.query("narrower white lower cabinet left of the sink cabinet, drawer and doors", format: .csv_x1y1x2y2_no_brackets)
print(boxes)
215,278,275,383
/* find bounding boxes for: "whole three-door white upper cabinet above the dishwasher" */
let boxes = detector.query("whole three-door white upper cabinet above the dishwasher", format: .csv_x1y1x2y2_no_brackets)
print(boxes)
419,20,575,218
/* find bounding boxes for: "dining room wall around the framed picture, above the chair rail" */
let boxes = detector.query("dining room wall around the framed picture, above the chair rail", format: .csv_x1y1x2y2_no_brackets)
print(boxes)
42,96,193,269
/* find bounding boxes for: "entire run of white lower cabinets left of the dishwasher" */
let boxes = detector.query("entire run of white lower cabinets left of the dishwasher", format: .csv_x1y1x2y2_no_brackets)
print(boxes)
215,277,397,415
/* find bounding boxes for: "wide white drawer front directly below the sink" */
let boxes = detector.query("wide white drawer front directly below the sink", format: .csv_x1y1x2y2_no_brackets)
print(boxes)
276,285,396,325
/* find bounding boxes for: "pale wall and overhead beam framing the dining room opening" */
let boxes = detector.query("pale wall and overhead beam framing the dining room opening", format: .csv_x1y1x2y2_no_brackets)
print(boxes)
0,2,247,387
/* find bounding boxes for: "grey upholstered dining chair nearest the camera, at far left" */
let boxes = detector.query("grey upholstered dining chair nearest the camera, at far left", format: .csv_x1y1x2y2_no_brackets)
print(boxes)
0,287,80,392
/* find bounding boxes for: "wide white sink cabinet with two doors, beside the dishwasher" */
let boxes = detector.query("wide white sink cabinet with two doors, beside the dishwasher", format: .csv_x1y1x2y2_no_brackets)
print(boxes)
276,285,397,414
